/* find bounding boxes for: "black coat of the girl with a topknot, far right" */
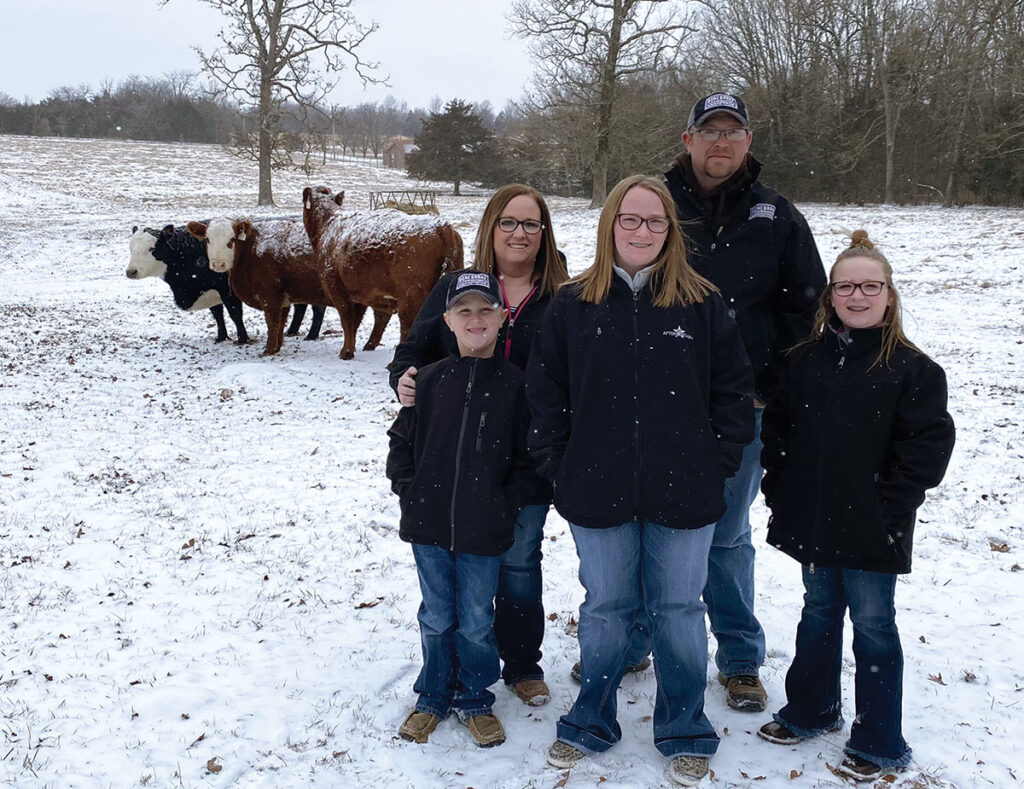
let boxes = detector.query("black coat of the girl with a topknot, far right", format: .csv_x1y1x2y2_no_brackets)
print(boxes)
761,328,955,573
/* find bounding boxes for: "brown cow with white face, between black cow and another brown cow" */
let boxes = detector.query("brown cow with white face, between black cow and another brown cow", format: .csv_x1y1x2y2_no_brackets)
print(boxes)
188,212,391,356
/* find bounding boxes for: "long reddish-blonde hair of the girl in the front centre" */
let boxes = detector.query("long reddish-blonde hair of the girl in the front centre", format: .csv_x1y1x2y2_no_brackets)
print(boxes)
570,175,718,307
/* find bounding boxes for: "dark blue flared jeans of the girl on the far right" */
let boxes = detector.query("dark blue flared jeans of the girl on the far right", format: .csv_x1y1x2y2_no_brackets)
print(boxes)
775,565,910,769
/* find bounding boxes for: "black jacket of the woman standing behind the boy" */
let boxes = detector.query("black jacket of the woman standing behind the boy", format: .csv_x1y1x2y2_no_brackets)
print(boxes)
388,271,551,505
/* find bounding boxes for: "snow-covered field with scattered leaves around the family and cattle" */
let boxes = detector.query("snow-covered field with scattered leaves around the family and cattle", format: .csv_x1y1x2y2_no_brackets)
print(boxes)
0,137,1024,789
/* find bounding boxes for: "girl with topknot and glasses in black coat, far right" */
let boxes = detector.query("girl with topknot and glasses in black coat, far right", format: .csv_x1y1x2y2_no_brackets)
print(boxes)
758,230,954,781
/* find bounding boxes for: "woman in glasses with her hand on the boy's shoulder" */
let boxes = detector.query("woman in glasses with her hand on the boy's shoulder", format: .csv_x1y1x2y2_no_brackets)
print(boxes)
388,183,568,706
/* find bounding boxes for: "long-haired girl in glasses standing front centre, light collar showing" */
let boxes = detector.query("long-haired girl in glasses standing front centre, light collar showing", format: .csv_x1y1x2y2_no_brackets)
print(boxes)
526,175,754,786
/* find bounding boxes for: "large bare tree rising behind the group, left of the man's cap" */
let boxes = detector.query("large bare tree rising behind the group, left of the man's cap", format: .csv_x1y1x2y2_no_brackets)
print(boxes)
509,0,692,206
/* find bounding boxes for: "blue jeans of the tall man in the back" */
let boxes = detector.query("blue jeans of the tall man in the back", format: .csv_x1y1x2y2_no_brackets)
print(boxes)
703,408,765,677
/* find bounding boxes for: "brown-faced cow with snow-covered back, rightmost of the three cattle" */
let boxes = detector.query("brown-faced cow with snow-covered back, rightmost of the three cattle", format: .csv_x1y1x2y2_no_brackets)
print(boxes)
302,186,462,359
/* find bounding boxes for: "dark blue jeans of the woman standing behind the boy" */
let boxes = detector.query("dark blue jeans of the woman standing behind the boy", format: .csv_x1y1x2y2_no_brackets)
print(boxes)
495,505,548,685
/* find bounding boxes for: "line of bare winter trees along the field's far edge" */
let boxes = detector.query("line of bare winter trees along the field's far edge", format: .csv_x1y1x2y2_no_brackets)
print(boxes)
0,0,1024,205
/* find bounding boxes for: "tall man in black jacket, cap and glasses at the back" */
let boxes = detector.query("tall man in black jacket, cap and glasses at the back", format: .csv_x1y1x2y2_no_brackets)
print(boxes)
659,93,825,712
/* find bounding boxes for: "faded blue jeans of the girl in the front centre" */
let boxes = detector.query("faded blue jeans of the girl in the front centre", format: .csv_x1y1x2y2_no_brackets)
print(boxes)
557,521,718,758
